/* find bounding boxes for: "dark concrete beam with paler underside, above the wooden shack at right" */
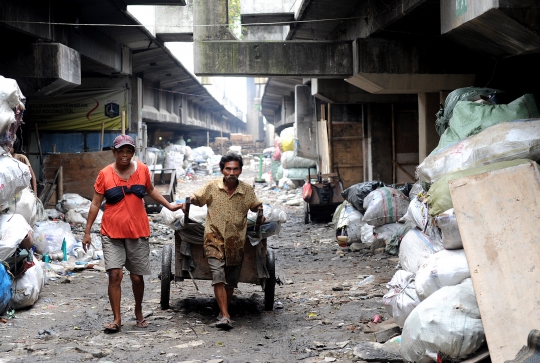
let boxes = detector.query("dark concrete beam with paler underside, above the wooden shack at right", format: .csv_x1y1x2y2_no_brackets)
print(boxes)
346,38,475,94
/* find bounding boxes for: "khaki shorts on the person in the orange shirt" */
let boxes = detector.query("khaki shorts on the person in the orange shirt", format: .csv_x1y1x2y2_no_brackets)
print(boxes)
101,236,150,275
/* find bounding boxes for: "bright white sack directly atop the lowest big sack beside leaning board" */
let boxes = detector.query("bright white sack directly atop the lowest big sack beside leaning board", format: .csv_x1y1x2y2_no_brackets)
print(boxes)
416,250,471,300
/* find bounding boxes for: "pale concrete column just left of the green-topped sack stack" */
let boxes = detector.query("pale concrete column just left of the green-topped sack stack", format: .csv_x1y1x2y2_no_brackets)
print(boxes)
418,93,441,162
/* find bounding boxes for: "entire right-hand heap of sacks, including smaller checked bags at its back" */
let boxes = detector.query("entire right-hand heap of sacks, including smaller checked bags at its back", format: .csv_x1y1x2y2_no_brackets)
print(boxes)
334,87,540,362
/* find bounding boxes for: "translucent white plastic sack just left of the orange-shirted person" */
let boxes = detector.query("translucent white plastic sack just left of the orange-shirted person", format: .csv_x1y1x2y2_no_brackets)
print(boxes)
34,221,77,255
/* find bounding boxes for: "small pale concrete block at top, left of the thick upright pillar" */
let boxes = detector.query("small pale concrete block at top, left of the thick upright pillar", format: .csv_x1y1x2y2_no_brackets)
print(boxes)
154,0,193,42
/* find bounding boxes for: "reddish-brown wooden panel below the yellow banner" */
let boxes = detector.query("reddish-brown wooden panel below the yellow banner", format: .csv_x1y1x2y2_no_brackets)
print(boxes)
43,150,114,199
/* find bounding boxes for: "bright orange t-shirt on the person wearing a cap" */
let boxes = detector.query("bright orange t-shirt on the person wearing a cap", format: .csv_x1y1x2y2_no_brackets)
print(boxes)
94,161,152,239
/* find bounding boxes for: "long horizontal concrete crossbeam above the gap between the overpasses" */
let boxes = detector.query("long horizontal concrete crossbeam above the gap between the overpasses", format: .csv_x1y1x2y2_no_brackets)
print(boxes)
194,41,352,78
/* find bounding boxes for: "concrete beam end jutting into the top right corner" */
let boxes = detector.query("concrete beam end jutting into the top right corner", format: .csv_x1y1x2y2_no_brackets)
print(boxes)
441,0,540,58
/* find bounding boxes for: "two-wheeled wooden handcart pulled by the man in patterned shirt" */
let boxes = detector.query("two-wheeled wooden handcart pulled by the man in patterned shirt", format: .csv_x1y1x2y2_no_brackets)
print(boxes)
160,209,276,311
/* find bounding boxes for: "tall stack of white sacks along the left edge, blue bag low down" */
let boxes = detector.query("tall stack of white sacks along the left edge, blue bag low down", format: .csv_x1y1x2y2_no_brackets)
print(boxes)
0,76,45,315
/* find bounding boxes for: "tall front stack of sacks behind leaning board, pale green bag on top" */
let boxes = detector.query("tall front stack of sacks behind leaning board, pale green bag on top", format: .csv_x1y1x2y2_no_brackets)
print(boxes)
390,95,540,362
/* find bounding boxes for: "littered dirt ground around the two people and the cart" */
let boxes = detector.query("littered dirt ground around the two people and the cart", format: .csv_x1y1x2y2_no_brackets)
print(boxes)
0,172,397,363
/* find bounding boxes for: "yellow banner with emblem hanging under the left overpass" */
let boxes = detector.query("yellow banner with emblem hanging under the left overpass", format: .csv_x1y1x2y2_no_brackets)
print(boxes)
24,89,129,131
